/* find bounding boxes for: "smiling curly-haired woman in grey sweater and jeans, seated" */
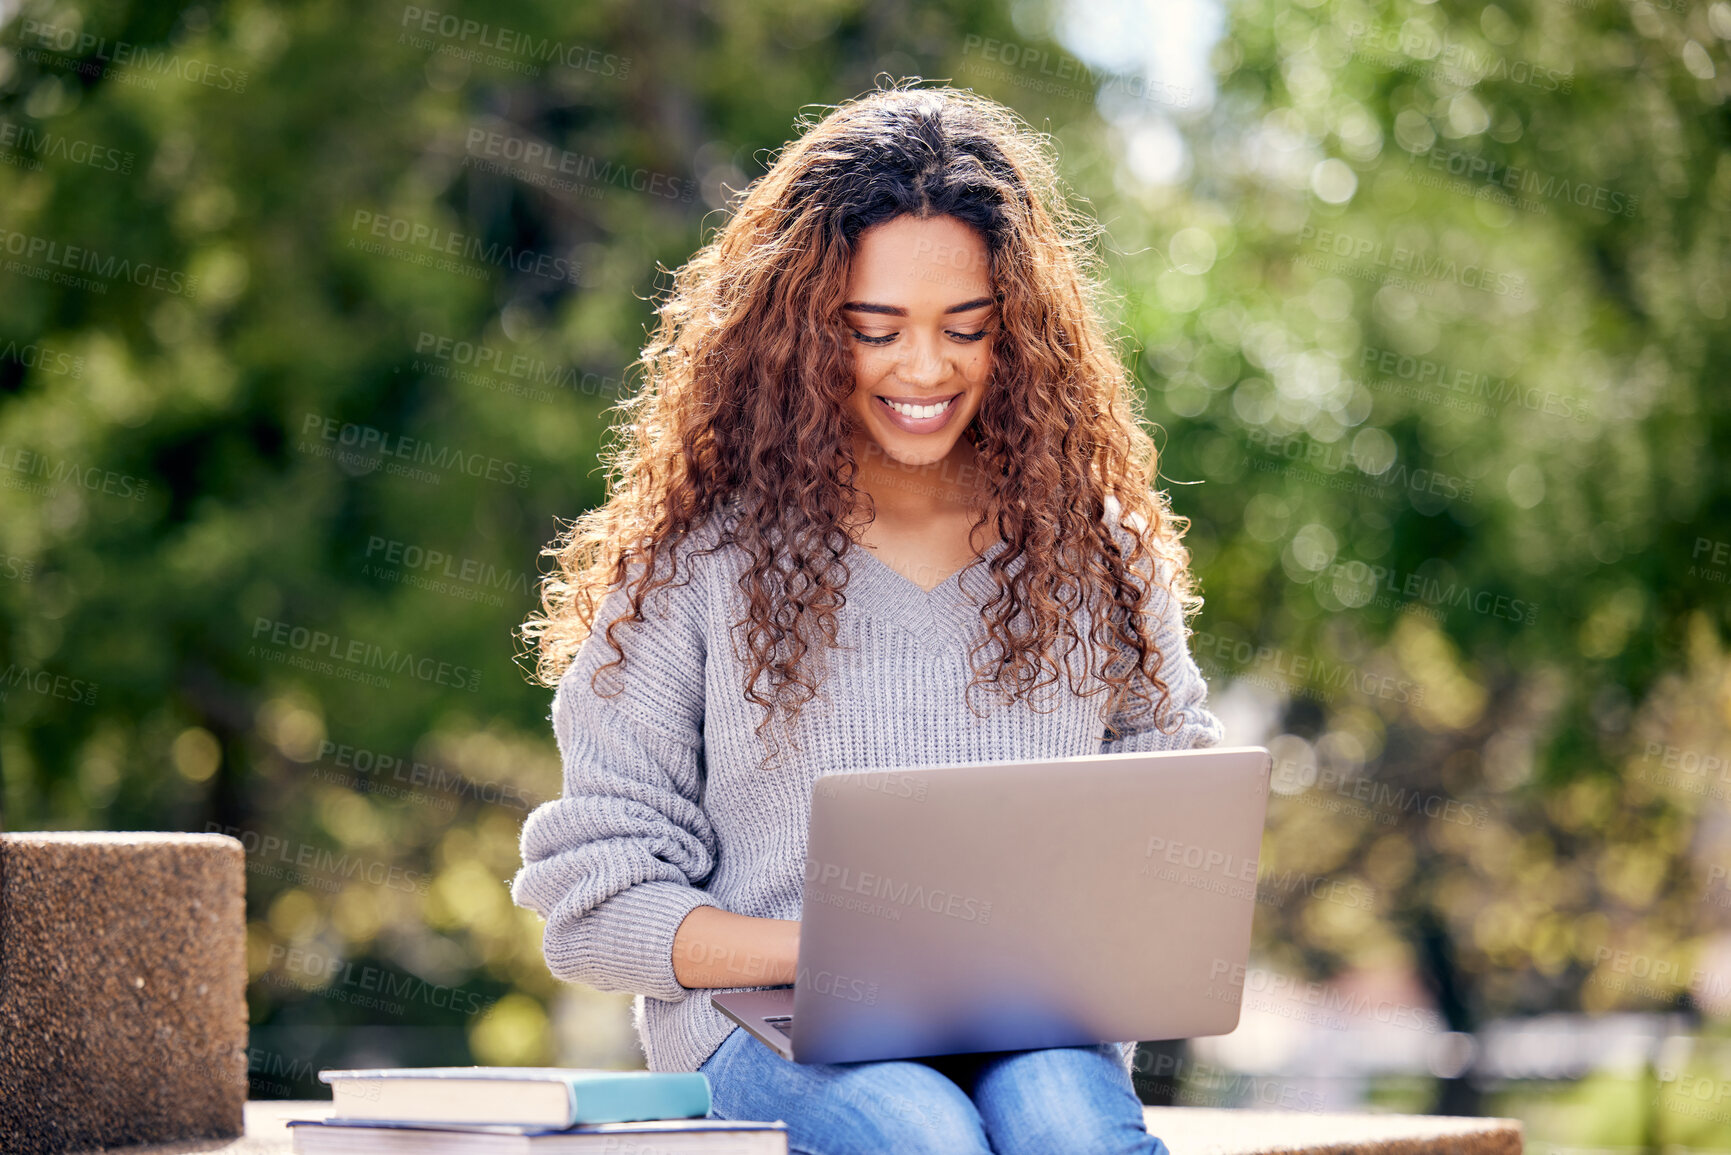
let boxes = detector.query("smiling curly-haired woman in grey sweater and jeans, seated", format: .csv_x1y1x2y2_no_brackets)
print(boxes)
512,87,1220,1155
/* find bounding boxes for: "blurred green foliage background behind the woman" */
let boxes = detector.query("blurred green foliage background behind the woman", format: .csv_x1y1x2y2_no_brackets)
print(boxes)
0,0,1731,1138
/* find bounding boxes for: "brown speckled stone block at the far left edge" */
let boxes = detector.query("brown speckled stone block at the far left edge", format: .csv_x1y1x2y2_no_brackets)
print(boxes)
0,833,246,1155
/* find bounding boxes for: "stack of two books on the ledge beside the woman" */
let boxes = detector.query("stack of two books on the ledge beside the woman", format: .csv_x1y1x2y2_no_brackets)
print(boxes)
289,1067,788,1155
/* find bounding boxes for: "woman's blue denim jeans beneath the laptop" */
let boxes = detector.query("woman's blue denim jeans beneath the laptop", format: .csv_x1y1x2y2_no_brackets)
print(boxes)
698,1027,1168,1155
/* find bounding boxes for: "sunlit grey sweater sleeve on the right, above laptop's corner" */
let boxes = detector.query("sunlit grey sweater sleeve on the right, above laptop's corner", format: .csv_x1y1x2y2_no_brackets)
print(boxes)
1099,502,1224,753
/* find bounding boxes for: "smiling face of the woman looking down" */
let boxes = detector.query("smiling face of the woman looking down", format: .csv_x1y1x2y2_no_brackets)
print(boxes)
841,216,997,477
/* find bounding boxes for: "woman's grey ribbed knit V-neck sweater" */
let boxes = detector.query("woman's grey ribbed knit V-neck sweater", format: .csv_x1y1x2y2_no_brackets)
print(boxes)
511,502,1220,1070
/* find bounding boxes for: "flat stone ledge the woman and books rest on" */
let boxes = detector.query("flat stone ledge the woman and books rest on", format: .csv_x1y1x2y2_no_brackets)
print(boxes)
64,1101,1522,1155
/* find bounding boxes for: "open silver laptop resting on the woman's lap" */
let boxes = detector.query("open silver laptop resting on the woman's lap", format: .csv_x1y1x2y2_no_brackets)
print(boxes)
713,746,1269,1063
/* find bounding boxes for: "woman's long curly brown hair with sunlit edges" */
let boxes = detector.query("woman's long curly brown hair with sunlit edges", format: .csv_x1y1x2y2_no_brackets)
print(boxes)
519,81,1201,768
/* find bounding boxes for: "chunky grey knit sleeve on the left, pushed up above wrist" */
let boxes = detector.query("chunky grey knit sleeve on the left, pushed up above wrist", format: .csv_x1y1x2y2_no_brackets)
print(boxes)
511,566,718,1003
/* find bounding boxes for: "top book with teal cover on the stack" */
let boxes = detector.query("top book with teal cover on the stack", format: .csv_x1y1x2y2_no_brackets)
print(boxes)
319,1067,710,1127
